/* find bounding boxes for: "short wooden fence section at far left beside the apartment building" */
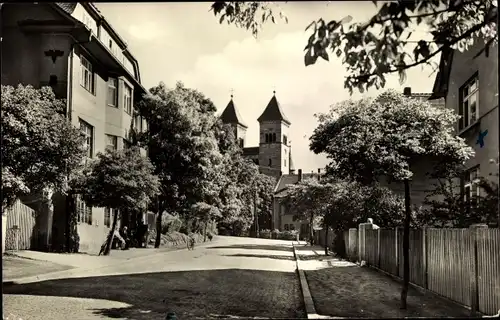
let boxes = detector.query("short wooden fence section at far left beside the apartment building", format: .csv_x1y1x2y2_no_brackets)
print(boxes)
5,200,36,250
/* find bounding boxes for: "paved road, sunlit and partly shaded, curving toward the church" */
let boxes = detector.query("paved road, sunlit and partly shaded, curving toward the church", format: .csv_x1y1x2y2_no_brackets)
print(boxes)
3,237,304,320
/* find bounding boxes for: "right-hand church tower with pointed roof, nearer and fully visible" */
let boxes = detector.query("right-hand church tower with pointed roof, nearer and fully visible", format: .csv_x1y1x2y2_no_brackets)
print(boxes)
257,91,291,177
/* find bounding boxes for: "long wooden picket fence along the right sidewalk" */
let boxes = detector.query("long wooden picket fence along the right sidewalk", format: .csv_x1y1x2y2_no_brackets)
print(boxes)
344,228,500,314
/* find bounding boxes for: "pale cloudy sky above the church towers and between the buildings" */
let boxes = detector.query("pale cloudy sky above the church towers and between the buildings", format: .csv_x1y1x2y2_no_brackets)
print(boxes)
96,1,436,172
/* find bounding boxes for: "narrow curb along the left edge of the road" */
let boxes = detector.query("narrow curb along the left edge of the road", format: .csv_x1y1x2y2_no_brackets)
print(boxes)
2,236,221,285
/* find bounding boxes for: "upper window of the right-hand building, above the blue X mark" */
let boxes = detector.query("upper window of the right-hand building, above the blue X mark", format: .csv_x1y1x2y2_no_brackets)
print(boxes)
458,73,479,130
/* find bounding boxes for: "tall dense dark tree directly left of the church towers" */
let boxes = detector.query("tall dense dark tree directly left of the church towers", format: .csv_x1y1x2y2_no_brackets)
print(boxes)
137,82,224,247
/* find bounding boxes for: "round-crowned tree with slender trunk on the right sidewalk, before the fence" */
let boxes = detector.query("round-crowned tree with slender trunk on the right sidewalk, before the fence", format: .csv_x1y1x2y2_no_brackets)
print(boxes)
310,90,473,308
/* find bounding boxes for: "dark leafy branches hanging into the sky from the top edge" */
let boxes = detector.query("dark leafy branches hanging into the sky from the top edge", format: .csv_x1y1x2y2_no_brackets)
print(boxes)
211,0,498,93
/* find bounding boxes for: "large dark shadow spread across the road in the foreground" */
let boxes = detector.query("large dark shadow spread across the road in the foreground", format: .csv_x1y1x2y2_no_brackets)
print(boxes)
3,269,304,320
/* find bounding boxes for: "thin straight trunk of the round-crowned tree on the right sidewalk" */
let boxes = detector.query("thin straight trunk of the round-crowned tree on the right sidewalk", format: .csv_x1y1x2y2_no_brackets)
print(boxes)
401,179,411,309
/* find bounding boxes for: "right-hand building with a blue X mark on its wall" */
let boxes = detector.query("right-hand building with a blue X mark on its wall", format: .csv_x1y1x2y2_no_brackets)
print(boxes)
431,39,499,212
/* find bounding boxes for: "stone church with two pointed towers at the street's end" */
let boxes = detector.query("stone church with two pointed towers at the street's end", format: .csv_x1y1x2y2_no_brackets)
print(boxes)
220,92,319,236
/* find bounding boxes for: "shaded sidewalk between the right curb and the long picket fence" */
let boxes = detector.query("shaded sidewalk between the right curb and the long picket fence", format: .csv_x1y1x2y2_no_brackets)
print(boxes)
296,246,470,318
